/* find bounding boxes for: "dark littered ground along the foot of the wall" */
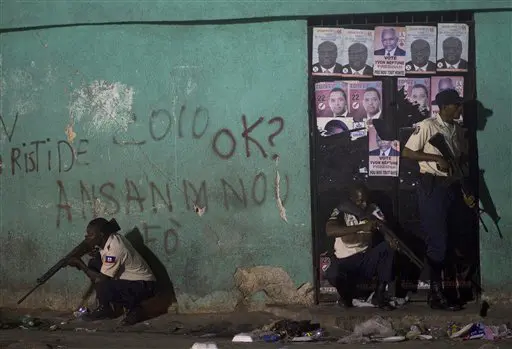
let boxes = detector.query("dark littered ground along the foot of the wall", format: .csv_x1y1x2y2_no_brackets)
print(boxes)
0,303,512,349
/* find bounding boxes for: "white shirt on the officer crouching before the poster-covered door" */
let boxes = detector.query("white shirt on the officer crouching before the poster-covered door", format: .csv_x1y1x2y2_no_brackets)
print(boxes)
329,206,384,258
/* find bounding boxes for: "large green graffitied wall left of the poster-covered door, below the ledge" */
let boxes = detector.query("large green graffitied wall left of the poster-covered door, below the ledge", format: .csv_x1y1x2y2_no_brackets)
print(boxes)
0,21,313,309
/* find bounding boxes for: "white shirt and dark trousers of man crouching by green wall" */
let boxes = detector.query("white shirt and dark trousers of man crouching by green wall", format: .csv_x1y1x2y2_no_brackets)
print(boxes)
89,233,156,310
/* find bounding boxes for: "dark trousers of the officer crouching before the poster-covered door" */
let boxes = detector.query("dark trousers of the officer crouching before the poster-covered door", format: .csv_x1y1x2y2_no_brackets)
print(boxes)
325,241,395,295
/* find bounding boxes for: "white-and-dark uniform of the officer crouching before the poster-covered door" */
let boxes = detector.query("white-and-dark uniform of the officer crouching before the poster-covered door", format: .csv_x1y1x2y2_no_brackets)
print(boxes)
326,206,394,302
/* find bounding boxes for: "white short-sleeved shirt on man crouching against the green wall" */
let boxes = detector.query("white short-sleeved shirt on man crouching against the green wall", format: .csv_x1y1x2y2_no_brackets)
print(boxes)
100,233,156,281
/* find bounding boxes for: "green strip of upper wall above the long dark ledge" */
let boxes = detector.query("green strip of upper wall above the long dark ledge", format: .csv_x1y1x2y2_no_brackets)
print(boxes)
0,0,512,28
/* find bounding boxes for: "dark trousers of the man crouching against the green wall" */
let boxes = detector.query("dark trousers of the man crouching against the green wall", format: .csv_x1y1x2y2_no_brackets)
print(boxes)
88,253,156,310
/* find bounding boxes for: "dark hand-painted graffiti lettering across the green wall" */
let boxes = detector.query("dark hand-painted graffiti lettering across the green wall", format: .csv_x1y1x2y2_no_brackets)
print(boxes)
0,92,290,255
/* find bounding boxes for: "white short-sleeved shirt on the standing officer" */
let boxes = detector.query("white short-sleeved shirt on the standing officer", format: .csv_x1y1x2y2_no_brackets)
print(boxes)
405,115,467,176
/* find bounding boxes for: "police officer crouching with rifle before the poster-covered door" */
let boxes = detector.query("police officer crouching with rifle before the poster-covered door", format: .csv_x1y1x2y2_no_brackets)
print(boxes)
325,184,395,310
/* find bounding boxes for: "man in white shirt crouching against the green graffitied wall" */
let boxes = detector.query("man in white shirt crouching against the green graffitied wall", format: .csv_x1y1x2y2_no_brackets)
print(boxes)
68,218,156,325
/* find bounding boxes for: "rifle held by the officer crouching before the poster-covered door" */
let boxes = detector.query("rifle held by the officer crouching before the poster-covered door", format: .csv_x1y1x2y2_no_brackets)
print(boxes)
337,201,424,270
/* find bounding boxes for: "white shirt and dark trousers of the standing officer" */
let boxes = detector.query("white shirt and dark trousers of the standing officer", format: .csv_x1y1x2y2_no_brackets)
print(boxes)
405,115,467,282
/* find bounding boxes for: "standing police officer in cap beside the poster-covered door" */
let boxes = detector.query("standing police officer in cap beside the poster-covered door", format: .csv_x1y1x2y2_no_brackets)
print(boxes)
403,89,467,310
